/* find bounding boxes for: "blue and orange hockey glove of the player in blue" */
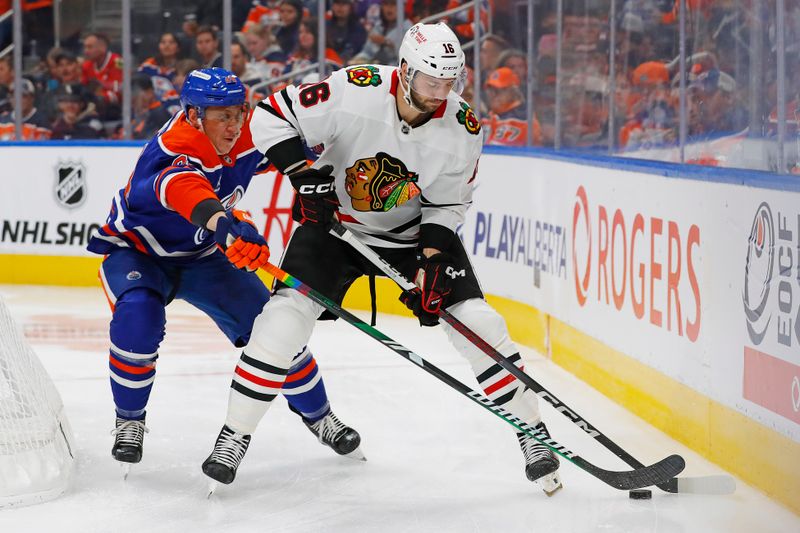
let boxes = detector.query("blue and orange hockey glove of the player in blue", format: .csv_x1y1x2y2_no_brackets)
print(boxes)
214,210,269,272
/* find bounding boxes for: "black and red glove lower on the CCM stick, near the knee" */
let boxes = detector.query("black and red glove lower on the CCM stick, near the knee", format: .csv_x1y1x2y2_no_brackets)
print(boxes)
400,252,459,326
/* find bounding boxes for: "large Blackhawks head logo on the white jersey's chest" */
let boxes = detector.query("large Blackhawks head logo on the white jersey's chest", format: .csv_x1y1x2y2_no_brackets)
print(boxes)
344,152,420,212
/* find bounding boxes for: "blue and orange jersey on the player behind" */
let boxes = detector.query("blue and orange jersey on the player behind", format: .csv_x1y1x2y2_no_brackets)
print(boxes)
88,111,269,262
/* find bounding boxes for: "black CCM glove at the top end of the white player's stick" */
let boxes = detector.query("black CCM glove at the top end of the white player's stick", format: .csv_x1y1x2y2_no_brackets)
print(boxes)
289,165,339,230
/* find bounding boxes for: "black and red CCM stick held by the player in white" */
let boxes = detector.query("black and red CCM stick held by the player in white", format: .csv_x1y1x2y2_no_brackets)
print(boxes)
331,223,736,494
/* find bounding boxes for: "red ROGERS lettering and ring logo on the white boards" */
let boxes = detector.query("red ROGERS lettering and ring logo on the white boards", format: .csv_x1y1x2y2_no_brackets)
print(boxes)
572,185,701,342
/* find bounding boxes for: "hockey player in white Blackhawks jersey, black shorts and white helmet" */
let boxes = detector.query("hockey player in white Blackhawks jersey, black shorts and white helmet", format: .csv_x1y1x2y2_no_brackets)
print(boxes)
200,23,561,494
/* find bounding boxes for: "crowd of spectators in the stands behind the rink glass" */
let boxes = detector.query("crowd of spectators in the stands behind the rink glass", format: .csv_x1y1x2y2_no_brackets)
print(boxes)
0,0,800,172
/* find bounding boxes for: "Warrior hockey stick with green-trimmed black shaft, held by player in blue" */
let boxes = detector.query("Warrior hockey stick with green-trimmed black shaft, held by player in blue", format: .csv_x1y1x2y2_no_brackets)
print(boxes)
261,263,686,490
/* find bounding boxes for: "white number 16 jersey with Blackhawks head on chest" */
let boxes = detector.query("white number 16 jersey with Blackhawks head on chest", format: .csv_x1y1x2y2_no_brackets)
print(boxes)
250,65,483,248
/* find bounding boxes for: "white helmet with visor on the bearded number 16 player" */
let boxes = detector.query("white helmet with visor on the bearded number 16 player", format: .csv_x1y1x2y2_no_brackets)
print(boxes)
398,22,466,104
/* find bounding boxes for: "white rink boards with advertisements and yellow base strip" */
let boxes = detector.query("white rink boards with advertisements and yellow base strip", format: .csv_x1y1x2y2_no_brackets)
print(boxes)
0,144,800,513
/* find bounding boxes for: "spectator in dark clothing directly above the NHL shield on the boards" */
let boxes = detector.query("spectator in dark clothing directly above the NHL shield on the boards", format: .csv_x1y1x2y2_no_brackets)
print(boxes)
52,84,104,139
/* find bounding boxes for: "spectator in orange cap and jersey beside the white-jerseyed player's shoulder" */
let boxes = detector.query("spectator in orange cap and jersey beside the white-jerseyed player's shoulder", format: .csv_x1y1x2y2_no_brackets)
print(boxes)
481,67,542,146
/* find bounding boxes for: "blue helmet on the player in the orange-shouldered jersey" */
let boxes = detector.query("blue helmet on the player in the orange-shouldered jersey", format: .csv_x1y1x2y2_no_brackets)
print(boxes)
181,67,246,118
